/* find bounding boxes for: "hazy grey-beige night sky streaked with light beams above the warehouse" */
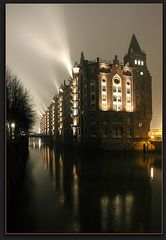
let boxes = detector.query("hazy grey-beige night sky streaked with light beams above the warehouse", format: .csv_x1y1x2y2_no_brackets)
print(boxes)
6,4,162,129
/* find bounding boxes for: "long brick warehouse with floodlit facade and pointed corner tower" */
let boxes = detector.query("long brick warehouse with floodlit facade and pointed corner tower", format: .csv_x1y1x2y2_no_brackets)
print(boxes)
40,34,152,150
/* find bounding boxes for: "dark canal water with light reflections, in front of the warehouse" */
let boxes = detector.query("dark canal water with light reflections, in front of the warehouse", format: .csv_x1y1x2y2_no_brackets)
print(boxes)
7,138,162,233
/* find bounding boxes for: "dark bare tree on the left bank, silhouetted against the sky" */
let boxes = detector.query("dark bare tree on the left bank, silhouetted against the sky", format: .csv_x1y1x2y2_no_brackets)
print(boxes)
5,68,35,139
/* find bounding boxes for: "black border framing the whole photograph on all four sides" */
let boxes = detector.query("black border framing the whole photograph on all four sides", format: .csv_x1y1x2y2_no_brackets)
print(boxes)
0,0,166,240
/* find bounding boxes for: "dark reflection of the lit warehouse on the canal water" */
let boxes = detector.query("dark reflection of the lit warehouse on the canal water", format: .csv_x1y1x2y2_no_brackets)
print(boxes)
26,139,161,233
